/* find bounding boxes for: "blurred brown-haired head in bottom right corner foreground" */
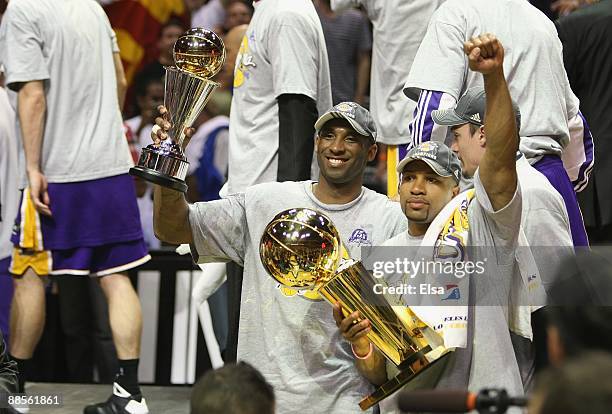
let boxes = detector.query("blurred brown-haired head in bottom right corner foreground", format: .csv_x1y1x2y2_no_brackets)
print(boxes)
529,352,612,414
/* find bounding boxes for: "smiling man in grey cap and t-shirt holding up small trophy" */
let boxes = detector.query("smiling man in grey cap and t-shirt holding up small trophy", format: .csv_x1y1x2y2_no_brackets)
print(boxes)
153,102,406,413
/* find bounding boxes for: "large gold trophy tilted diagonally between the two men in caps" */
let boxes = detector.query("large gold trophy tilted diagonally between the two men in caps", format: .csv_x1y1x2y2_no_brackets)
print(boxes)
259,208,448,410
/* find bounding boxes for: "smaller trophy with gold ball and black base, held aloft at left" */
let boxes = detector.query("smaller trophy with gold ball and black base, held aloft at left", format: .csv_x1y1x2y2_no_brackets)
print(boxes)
130,28,225,192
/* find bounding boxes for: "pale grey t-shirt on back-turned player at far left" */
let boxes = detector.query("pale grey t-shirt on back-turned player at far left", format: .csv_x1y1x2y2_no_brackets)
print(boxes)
0,0,133,184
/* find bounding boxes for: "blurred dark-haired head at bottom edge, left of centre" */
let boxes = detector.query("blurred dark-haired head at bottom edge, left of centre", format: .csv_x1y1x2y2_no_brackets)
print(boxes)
191,362,275,414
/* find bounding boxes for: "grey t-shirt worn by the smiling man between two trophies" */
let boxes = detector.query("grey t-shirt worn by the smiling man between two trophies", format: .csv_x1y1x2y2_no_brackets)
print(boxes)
189,181,406,413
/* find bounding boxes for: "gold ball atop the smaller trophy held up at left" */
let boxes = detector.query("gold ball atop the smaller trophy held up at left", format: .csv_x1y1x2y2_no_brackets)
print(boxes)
173,27,225,79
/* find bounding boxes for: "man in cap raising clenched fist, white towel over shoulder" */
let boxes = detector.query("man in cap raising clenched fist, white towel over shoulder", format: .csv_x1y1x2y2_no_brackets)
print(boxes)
335,34,523,408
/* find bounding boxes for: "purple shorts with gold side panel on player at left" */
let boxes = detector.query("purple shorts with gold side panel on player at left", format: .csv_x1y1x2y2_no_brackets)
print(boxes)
9,174,150,276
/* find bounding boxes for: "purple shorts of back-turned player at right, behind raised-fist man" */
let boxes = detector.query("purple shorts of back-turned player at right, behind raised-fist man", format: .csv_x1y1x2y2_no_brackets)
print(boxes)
533,155,589,246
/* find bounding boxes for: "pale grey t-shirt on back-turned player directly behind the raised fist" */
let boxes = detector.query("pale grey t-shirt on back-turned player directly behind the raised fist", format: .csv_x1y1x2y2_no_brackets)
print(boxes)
404,0,579,159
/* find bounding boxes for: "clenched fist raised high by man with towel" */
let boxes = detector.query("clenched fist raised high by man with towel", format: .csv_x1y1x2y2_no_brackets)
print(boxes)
463,33,504,75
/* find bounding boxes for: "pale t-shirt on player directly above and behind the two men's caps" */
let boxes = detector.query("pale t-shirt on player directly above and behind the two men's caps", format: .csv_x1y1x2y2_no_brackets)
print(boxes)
331,0,445,145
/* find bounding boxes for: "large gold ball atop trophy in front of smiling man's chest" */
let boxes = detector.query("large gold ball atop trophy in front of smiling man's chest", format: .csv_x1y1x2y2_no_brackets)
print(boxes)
259,208,341,289
